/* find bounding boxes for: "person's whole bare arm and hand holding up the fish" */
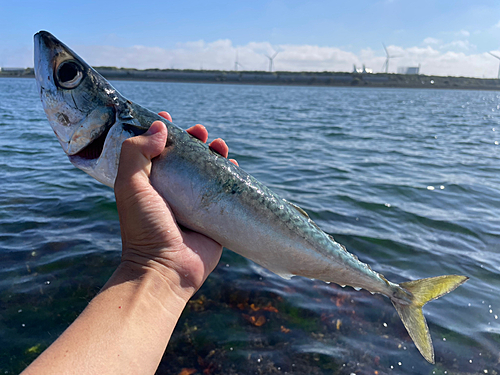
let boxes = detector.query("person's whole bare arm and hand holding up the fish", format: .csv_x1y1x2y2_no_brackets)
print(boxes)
24,113,233,374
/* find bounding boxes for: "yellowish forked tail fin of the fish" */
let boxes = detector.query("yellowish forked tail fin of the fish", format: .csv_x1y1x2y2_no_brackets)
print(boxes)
392,275,469,363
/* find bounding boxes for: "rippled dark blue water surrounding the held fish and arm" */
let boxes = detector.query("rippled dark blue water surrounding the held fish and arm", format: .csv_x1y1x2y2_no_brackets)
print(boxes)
0,79,500,374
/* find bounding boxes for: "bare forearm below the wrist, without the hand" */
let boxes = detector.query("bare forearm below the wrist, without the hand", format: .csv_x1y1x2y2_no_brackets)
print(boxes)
20,263,192,375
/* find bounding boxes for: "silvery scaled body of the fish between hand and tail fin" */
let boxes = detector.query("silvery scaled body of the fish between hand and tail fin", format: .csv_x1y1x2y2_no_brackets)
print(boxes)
151,124,394,295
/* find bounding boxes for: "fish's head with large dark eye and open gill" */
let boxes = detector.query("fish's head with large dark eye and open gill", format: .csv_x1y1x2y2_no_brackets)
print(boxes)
34,31,147,187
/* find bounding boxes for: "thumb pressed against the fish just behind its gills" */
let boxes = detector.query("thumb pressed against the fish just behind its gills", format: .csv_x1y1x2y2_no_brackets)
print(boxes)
115,121,168,195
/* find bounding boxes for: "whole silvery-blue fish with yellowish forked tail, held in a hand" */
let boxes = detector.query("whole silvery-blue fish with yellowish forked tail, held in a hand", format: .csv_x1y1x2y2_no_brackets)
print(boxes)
34,31,468,363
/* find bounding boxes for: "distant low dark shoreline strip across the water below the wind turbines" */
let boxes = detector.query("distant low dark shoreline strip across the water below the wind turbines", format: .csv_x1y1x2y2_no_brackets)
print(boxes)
0,67,500,91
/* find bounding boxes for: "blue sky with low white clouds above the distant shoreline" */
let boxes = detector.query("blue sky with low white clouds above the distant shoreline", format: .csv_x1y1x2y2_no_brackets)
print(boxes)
0,0,500,78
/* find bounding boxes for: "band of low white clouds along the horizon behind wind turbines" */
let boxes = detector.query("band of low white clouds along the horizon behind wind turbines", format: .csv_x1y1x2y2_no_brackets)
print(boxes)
20,38,499,78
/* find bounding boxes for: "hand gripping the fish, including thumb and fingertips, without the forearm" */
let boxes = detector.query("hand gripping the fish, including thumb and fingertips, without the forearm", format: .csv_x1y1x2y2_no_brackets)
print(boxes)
115,112,237,298
